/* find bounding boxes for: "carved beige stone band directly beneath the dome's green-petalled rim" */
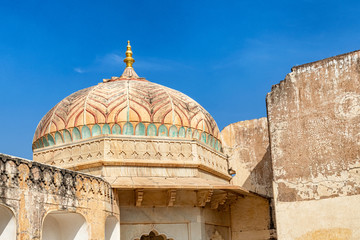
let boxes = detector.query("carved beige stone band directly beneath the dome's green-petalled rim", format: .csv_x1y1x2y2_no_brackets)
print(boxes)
34,135,231,180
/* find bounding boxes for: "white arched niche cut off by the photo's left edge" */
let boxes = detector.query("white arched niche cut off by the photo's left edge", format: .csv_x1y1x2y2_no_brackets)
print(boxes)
0,205,16,240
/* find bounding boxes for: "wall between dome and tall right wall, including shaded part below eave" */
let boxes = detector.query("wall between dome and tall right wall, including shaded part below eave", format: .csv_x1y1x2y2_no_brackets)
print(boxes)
221,118,276,240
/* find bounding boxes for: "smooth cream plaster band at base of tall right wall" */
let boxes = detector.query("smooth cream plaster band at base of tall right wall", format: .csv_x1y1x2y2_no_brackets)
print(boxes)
276,195,360,240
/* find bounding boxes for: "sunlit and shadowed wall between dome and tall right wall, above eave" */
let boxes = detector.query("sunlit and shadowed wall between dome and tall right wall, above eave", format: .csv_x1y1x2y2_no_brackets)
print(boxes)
221,118,272,197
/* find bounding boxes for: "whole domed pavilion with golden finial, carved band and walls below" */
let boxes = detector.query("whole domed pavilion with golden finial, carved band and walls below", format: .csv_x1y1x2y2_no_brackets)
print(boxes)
32,42,252,239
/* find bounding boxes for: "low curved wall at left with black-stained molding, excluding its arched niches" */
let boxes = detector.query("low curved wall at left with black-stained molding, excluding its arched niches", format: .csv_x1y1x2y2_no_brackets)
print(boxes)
0,154,119,240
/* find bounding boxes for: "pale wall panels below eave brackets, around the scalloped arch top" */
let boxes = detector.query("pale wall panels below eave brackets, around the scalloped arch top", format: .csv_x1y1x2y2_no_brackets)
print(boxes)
120,207,230,240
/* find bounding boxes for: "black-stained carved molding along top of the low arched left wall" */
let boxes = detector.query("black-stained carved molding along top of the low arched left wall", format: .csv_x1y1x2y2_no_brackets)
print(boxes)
0,154,114,202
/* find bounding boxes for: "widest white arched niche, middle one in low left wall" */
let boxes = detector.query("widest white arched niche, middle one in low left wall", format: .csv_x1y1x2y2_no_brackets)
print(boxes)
42,212,89,240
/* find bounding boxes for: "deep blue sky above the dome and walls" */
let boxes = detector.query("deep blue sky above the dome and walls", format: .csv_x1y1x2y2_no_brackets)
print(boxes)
0,0,360,159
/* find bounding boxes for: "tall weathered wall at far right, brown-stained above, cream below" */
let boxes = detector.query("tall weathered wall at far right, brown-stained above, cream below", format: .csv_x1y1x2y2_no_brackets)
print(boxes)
267,51,360,239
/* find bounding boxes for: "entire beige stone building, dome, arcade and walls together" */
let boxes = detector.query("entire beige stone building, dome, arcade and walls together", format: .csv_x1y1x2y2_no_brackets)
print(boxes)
0,44,360,240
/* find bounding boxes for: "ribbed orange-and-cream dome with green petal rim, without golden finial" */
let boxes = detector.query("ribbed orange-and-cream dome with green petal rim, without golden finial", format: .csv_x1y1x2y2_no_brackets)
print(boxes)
33,78,221,150
